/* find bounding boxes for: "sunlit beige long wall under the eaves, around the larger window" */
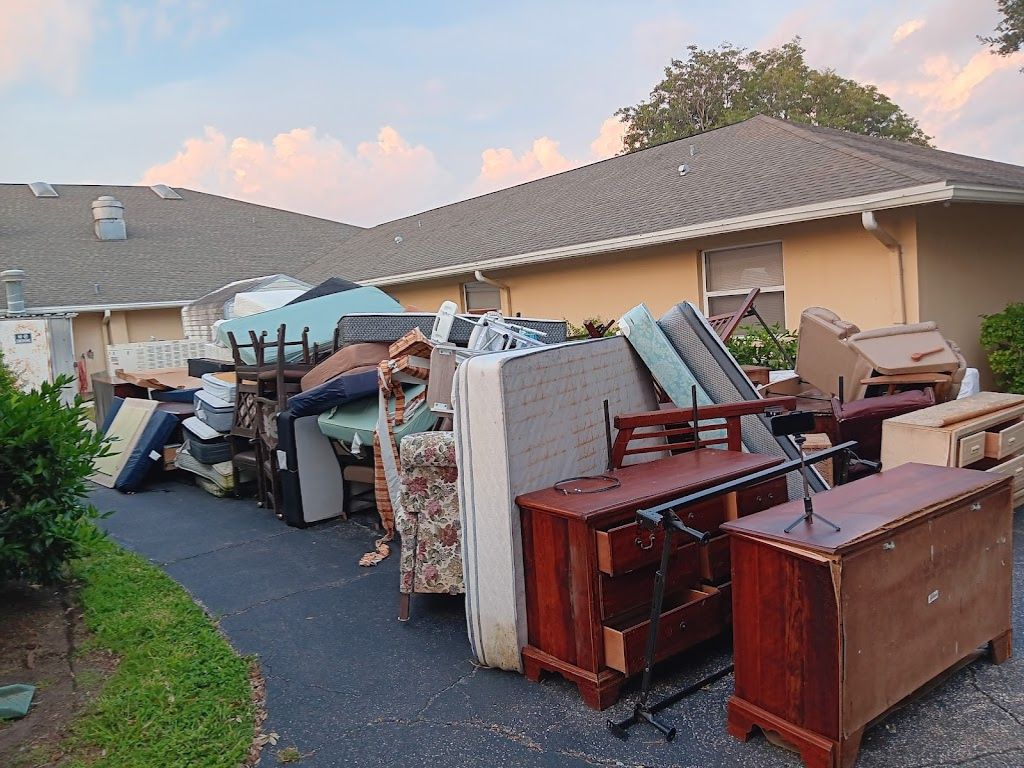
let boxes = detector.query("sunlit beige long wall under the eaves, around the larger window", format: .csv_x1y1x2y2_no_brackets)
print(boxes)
384,210,919,329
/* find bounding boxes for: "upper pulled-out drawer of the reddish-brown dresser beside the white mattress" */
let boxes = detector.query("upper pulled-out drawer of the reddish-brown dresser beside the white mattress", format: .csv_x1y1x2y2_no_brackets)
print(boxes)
594,499,725,575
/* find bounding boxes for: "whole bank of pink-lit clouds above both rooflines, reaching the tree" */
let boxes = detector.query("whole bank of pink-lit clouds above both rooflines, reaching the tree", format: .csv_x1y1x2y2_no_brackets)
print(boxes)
138,118,625,225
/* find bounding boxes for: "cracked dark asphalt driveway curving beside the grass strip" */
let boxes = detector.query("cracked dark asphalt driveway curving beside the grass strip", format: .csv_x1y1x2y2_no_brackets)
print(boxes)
92,480,1024,768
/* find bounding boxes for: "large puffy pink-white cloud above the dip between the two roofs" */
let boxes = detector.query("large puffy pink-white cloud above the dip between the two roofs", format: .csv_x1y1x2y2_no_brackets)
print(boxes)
139,126,452,225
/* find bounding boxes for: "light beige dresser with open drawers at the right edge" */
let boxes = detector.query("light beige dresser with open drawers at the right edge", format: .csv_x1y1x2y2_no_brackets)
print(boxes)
882,392,1024,507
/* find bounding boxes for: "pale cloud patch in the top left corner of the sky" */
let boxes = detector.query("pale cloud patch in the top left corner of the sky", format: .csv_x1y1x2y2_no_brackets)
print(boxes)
0,0,93,94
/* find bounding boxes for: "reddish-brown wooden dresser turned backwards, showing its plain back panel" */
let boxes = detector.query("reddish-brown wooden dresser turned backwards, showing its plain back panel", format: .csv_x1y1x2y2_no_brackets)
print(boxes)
722,464,1014,768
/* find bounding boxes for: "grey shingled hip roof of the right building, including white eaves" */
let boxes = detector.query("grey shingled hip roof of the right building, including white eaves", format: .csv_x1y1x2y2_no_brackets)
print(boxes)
298,116,1024,285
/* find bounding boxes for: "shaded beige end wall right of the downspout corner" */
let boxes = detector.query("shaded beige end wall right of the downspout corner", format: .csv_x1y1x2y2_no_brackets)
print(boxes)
918,203,1024,388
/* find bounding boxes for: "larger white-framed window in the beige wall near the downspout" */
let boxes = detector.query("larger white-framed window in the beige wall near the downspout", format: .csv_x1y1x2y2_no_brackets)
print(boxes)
703,243,785,327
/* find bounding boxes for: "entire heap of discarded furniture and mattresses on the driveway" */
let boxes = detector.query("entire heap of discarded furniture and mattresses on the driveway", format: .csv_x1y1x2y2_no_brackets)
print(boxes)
97,285,1024,766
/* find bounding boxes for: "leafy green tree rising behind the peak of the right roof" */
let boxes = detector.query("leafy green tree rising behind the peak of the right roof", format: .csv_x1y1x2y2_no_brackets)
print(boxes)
615,39,933,152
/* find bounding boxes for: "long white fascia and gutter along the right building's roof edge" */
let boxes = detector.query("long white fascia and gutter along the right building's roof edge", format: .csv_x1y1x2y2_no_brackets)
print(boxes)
360,181,1024,286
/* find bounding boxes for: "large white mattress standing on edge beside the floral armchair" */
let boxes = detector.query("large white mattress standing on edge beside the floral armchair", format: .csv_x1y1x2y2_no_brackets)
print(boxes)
455,337,657,671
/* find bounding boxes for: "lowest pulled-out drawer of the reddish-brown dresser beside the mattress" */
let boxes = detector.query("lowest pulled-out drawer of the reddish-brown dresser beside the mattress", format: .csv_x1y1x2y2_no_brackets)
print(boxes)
603,587,724,675
